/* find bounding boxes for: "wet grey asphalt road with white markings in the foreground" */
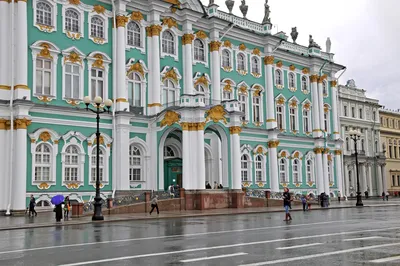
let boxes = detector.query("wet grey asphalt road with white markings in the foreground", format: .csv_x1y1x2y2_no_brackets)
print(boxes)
0,207,400,266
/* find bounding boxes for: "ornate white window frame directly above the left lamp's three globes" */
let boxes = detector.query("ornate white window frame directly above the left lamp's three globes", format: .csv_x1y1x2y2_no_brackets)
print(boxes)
87,51,111,99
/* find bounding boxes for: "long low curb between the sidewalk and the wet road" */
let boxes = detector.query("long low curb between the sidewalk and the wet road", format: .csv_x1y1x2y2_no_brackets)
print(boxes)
0,204,400,232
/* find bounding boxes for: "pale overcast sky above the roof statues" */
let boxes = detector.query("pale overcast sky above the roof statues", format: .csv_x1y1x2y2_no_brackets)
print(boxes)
201,0,400,109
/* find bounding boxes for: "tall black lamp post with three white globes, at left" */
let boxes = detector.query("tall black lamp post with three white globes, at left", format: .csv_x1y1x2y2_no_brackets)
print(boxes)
83,96,112,221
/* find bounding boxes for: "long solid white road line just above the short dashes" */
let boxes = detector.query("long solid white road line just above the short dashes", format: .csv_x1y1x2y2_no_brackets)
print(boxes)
60,227,400,266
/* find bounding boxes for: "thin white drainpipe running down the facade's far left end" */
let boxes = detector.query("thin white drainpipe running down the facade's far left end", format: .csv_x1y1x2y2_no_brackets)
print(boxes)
6,1,15,216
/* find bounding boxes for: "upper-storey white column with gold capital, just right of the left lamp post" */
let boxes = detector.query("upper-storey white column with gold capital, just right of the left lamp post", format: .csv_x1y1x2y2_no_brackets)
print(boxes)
115,16,129,111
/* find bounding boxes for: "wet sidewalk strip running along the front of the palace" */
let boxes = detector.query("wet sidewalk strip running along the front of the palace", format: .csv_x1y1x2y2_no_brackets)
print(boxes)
0,198,400,231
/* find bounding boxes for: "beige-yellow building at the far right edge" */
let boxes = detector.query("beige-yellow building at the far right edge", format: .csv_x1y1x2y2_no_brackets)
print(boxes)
379,109,400,195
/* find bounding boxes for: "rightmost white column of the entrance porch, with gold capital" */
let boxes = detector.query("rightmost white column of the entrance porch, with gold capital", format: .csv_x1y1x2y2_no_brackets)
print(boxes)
230,126,242,189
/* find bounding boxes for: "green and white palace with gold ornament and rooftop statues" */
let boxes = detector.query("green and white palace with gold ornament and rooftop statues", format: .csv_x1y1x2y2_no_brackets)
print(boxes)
0,0,344,210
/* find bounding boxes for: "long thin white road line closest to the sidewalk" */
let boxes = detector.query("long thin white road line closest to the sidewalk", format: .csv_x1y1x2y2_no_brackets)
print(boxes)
0,220,352,255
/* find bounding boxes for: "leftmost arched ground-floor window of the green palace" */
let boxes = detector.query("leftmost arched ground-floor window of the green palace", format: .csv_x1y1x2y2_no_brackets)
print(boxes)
35,143,51,181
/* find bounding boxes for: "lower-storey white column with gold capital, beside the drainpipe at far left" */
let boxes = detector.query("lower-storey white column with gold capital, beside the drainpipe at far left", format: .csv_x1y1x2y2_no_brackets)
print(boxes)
10,118,31,211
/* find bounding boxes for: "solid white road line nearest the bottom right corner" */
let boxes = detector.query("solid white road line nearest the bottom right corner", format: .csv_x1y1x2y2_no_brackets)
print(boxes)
239,243,400,266
